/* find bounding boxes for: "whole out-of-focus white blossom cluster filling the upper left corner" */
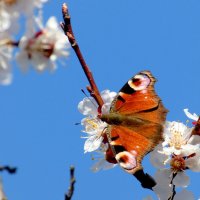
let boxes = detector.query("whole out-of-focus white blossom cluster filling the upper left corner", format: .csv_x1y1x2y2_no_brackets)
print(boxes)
0,0,69,85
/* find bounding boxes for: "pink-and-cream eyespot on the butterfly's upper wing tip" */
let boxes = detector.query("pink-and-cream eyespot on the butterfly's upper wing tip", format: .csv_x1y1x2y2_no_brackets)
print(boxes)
128,74,151,91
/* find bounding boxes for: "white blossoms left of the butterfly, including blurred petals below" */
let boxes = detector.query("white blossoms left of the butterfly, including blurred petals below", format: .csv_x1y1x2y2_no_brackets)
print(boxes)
78,90,117,172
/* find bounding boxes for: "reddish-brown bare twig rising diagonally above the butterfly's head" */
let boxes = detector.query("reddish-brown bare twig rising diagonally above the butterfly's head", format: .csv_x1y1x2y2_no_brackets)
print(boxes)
61,4,104,111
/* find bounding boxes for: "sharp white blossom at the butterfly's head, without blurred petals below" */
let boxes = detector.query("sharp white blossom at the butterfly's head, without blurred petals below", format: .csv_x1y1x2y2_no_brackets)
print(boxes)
78,90,116,153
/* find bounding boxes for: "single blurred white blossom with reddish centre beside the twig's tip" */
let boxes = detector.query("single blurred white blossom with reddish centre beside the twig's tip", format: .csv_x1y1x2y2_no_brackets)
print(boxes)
17,17,69,72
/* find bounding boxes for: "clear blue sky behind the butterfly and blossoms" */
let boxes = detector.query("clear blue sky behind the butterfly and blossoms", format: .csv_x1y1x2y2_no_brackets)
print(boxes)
0,0,200,200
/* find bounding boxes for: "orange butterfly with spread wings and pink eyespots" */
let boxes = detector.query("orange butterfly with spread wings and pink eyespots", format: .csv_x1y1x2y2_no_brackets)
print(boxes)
100,71,168,189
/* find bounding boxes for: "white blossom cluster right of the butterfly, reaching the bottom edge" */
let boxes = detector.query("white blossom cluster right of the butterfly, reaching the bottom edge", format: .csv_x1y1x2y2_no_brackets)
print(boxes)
150,109,200,200
